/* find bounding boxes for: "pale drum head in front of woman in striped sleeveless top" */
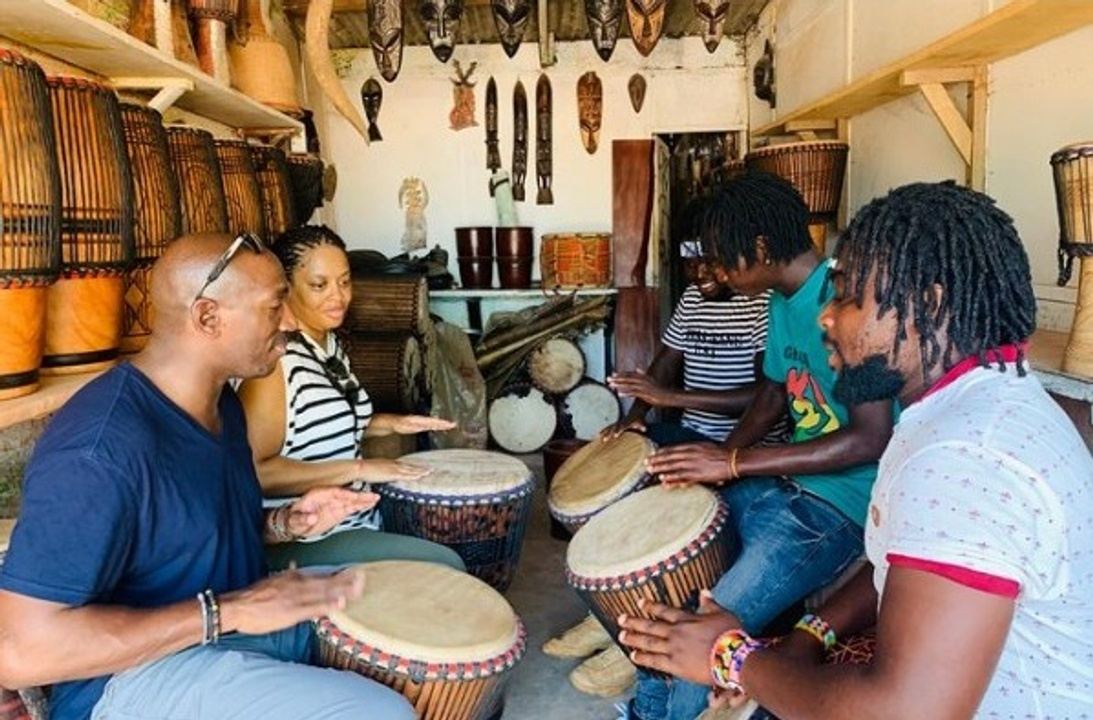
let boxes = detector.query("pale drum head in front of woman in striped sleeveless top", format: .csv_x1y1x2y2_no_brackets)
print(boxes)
385,450,532,497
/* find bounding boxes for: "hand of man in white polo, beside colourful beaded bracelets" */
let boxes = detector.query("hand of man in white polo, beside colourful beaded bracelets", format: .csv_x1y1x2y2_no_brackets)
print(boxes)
619,590,740,685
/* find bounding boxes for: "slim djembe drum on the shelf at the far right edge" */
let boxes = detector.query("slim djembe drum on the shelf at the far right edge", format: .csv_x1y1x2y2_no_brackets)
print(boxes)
1051,142,1093,377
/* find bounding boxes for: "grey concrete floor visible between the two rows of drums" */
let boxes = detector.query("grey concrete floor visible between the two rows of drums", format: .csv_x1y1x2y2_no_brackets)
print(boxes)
504,455,625,720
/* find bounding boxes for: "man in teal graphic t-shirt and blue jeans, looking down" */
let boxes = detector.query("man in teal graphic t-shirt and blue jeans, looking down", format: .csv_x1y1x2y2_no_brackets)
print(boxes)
631,173,893,720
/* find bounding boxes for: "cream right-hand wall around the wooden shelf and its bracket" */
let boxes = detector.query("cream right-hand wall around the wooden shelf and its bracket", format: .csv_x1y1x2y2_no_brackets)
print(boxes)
747,0,1093,330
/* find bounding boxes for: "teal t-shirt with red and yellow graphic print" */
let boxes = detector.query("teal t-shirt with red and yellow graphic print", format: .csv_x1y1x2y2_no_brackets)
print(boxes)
763,262,877,527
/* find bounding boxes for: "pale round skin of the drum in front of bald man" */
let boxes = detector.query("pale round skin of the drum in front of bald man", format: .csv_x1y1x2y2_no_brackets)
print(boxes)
330,560,522,663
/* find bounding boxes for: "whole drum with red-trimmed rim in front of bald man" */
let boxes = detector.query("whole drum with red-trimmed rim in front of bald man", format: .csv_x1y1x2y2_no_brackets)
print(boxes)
316,560,527,720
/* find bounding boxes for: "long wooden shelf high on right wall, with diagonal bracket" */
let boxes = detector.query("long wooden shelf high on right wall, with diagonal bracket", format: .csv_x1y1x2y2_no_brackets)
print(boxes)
752,0,1093,137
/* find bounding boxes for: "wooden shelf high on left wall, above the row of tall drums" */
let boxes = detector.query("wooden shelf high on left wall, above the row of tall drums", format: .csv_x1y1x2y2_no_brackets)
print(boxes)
0,0,303,131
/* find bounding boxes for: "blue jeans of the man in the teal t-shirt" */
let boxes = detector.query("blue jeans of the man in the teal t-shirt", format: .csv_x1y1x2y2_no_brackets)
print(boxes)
631,477,862,720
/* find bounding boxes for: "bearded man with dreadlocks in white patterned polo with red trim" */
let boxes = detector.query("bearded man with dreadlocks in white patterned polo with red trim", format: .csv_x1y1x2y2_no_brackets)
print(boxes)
621,182,1093,720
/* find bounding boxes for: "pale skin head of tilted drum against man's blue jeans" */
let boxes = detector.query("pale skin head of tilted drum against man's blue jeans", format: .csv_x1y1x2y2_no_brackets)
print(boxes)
565,485,721,579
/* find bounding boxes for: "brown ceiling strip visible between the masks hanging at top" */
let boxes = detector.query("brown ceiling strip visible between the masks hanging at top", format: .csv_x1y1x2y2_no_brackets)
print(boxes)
284,0,768,49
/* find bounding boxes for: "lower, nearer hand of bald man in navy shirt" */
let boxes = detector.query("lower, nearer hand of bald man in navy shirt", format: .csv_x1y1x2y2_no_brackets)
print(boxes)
220,569,364,635
